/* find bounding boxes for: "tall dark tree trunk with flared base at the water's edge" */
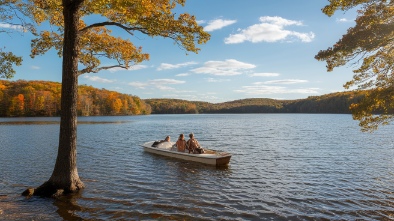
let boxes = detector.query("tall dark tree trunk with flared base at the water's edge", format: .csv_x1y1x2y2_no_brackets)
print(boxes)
24,0,84,196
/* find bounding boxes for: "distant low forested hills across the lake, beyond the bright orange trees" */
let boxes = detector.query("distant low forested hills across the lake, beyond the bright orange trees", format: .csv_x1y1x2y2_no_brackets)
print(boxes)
145,92,362,114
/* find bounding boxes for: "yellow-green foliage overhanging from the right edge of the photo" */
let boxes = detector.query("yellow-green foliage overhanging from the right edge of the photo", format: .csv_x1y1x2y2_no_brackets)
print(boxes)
315,0,394,131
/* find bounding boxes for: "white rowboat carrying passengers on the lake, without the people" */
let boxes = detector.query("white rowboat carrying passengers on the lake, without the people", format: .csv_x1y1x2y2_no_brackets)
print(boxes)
141,141,231,166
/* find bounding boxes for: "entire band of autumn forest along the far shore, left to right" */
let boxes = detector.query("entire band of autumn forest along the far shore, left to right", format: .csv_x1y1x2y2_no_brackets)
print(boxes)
0,80,363,117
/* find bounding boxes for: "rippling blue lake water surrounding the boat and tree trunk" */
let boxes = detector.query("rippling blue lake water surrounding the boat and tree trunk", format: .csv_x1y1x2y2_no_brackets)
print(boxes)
0,114,394,220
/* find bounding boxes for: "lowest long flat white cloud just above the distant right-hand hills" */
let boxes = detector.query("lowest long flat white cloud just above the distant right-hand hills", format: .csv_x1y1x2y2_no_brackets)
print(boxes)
235,85,319,95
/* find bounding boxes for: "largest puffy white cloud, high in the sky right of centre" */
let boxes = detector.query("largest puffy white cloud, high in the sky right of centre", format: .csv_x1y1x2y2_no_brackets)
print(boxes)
224,16,315,44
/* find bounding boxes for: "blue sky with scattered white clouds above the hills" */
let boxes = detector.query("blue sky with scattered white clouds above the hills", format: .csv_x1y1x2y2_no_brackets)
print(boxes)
0,0,356,103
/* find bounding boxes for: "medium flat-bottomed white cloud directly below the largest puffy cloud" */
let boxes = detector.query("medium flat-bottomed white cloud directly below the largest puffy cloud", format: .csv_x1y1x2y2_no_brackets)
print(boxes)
191,59,256,76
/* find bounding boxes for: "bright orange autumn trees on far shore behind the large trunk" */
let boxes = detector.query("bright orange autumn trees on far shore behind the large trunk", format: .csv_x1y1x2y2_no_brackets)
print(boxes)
0,80,151,117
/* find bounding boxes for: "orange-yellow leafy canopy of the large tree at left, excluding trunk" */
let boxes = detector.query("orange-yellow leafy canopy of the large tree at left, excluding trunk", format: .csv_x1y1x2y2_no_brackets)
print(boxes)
30,0,210,75
